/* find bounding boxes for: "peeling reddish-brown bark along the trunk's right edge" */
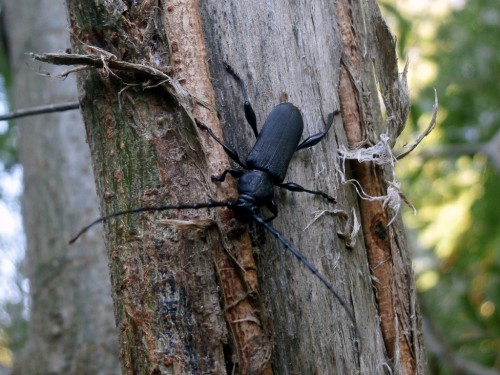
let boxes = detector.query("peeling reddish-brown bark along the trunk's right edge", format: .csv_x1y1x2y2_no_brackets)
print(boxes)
339,2,425,374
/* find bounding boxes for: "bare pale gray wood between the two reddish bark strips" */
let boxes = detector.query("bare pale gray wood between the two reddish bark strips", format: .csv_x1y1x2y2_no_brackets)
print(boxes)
202,1,387,374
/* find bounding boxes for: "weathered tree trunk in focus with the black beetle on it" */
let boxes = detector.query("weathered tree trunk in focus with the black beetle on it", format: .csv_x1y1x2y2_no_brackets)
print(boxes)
67,0,425,374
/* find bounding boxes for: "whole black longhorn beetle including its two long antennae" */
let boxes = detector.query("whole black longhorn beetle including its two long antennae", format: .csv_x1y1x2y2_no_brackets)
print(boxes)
70,63,357,331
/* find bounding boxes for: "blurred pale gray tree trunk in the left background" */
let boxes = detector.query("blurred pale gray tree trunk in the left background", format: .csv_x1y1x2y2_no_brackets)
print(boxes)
4,0,119,374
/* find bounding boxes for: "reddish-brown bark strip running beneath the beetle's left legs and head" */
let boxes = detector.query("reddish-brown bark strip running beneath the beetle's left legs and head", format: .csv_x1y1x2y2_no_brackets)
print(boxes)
165,0,271,374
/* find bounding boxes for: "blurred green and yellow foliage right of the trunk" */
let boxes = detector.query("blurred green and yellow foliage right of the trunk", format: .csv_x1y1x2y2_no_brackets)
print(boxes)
383,0,500,375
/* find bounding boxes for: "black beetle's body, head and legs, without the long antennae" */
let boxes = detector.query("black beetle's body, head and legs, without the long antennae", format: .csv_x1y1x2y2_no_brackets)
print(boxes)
196,64,339,222
